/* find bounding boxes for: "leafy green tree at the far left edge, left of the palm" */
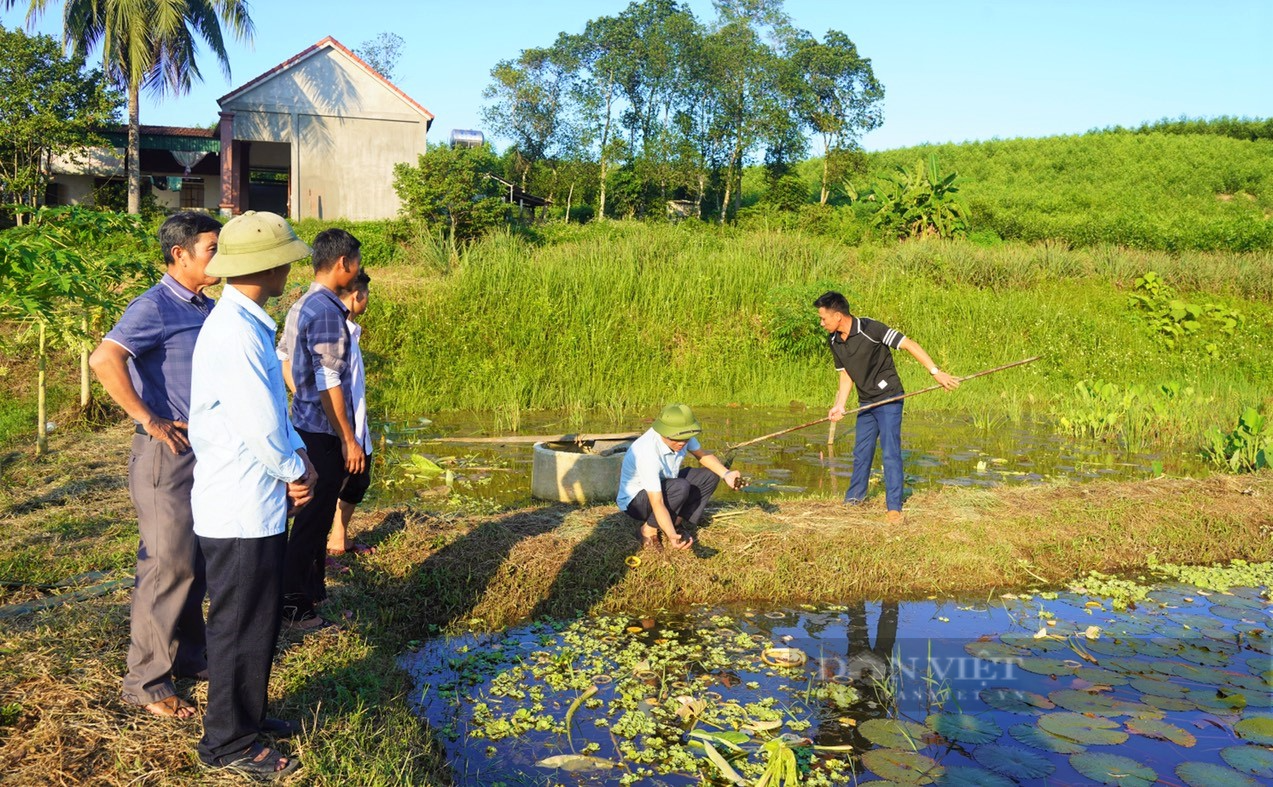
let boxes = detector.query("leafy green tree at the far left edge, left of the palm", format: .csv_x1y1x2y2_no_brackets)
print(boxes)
0,25,118,222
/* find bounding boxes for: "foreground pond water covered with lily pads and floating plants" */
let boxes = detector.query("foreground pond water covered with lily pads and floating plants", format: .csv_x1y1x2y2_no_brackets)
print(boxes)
404,585,1273,786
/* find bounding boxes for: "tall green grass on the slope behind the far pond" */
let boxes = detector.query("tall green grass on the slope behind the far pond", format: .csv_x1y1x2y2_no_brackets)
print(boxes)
365,223,1273,434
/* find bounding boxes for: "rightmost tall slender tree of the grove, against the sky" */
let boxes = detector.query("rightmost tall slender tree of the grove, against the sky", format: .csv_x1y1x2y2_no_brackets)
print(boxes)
792,31,883,205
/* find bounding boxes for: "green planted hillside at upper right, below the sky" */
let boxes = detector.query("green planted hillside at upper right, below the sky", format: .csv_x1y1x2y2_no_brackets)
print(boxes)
855,132,1273,251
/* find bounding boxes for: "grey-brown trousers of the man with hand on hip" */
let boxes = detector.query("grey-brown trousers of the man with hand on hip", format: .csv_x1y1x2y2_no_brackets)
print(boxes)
123,434,207,705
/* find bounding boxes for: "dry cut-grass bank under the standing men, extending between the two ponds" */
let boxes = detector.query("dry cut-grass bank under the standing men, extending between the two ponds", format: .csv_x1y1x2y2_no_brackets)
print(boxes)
0,427,1273,784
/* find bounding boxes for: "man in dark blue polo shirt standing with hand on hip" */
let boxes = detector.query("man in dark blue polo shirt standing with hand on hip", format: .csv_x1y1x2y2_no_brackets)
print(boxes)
89,213,222,718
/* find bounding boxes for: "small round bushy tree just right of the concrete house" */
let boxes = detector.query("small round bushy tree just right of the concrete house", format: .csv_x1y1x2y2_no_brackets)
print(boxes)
393,144,504,261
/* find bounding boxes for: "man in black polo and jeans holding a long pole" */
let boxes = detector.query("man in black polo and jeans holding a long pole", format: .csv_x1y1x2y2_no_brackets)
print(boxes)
813,292,959,523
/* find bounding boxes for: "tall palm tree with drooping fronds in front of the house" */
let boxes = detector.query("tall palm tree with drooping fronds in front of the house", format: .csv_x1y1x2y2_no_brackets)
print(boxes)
24,0,252,213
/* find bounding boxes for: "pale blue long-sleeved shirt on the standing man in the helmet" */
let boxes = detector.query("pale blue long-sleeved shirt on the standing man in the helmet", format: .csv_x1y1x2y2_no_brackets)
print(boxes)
190,284,306,539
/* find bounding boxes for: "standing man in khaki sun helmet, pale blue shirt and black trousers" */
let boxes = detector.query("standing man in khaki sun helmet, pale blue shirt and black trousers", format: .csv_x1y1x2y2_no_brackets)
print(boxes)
190,211,314,781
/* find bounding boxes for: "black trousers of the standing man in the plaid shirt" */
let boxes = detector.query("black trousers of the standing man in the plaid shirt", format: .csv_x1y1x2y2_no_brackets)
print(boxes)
283,429,348,620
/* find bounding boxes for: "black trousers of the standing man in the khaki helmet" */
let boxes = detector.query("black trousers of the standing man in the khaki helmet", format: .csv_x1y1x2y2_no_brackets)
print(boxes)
199,532,288,765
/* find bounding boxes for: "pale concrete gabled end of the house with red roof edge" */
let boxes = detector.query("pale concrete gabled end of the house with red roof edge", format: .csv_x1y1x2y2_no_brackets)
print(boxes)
218,38,433,219
